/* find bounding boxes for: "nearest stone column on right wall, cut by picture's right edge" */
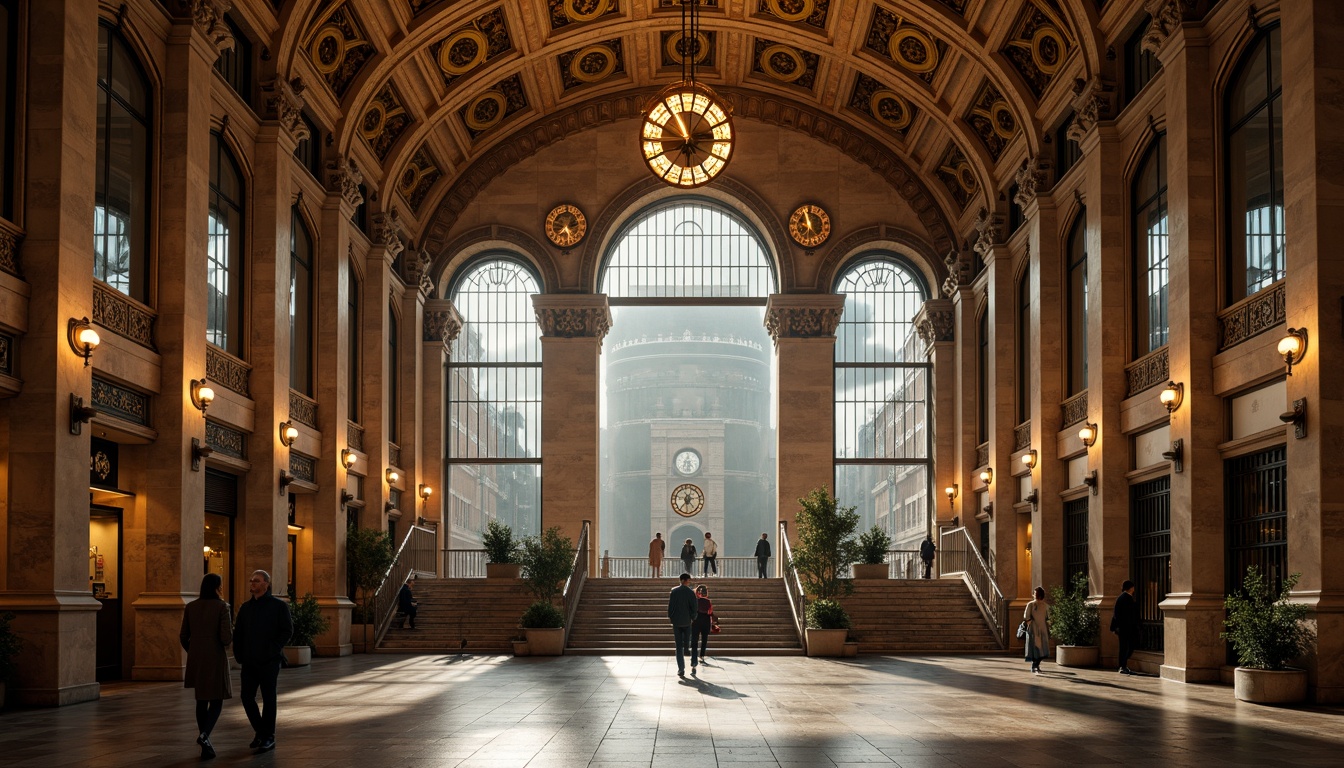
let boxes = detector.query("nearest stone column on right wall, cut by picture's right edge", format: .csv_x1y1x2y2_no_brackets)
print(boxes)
1281,0,1344,703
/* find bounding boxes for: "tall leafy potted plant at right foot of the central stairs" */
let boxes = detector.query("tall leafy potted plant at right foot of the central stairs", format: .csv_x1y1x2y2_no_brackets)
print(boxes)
789,486,859,656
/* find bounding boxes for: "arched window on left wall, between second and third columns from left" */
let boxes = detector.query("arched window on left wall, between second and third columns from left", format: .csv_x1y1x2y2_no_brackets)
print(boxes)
206,132,243,356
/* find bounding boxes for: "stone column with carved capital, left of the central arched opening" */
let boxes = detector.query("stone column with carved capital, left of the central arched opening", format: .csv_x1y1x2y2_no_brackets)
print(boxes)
532,293,612,573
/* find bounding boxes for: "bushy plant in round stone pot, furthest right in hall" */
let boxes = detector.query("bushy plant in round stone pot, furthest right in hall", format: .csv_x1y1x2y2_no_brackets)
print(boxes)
1220,565,1316,703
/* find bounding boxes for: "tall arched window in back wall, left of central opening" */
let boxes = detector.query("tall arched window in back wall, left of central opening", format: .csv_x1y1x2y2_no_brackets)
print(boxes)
448,253,542,546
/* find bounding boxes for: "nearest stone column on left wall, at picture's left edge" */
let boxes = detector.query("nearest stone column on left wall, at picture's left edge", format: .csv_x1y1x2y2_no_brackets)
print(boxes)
0,0,99,706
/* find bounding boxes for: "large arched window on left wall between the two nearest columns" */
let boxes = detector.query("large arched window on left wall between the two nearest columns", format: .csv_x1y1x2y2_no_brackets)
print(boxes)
93,24,152,301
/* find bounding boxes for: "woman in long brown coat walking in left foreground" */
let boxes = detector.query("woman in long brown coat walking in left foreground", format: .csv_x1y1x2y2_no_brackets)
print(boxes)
177,573,234,760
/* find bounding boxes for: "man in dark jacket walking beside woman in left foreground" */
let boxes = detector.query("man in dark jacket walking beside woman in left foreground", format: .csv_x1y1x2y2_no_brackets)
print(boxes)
234,570,294,752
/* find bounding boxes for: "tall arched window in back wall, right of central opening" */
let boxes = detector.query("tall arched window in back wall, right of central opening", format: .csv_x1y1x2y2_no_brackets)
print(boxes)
835,260,933,549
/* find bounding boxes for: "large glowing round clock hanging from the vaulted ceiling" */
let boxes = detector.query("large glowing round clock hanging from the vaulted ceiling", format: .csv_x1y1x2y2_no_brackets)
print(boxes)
640,83,732,190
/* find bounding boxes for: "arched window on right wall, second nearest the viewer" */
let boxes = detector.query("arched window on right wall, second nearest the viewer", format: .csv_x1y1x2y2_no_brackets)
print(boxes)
1133,135,1169,356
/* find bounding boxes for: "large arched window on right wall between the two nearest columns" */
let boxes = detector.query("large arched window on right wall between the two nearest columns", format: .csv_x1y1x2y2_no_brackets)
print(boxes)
1223,24,1288,303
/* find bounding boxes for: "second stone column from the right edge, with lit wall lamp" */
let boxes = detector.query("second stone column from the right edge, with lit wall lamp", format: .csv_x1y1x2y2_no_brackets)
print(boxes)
1150,23,1226,682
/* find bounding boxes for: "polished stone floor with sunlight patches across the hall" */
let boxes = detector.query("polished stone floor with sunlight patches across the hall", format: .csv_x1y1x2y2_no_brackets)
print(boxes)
0,655,1344,768
